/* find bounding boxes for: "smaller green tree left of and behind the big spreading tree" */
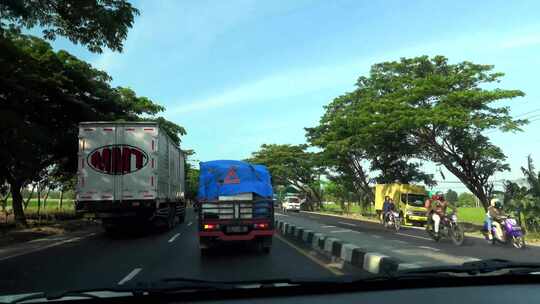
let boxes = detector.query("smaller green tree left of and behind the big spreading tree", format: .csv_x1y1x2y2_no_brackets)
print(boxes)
306,92,435,204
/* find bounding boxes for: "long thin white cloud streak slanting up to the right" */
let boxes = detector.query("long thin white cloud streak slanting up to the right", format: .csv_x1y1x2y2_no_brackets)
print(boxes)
167,27,540,115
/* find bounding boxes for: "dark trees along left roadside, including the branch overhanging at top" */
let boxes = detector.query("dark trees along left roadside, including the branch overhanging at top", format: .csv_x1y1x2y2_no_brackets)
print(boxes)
0,0,186,227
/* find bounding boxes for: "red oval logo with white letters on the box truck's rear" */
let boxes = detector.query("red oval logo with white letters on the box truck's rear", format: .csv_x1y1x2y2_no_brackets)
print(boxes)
86,145,148,175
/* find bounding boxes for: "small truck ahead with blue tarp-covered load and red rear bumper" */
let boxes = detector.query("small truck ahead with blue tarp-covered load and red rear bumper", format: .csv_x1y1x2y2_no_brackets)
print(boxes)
197,160,274,253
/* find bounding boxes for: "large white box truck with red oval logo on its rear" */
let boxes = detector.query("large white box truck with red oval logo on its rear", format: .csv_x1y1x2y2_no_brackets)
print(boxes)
76,122,186,231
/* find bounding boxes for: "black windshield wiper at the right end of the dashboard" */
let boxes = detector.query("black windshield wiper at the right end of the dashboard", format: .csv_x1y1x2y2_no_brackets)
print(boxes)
393,259,540,277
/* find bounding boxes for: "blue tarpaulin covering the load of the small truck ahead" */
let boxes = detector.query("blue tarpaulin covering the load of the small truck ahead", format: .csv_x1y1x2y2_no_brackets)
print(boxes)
197,160,273,201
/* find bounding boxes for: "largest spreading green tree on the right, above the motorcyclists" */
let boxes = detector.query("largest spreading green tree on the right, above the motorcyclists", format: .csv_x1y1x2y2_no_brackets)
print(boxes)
318,56,526,208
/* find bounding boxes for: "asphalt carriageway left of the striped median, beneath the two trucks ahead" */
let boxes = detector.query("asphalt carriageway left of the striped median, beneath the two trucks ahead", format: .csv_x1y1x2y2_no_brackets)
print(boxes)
0,210,336,295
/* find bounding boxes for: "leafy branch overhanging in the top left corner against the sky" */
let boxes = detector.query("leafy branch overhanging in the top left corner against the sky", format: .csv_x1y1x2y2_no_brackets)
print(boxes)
0,0,139,53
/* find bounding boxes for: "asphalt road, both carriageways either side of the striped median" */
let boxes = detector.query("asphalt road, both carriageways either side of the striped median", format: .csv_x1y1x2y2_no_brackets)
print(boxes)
0,210,540,295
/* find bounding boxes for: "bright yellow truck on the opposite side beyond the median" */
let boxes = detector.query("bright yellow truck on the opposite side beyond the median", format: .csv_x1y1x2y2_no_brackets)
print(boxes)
375,184,427,225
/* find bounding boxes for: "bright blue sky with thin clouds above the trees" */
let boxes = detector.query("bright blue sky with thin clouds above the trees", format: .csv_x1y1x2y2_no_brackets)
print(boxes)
45,0,540,191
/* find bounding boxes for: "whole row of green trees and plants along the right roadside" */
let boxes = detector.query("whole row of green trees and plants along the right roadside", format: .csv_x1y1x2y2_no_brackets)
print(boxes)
249,56,540,233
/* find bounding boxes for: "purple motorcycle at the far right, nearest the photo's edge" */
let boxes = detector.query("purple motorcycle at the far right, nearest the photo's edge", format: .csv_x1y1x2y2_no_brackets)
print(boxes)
482,216,525,249
